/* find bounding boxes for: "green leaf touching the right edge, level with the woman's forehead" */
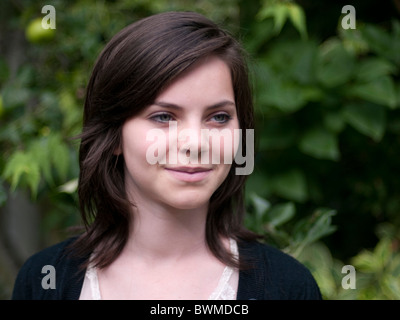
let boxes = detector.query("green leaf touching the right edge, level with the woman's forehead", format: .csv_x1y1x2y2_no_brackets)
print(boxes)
347,76,400,109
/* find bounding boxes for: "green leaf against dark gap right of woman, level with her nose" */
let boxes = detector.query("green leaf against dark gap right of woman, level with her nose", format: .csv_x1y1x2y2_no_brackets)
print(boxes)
299,127,340,161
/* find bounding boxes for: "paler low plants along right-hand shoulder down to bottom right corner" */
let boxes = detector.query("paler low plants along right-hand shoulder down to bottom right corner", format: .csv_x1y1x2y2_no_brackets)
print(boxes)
246,194,400,300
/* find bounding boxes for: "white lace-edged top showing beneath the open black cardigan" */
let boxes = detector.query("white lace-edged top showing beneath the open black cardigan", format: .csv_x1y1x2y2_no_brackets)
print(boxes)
79,239,239,300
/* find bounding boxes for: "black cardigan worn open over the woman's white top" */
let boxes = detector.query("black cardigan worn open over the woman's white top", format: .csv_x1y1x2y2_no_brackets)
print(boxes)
12,238,322,300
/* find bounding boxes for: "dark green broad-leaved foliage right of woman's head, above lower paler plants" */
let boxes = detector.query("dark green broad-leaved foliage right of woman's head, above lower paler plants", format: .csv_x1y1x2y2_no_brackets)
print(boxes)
247,1,400,232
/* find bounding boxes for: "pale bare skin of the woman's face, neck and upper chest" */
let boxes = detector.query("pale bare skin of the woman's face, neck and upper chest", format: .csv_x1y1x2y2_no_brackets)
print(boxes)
98,56,239,299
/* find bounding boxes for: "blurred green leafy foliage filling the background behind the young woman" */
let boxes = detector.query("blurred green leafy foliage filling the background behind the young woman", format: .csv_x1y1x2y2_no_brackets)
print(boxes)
0,0,400,299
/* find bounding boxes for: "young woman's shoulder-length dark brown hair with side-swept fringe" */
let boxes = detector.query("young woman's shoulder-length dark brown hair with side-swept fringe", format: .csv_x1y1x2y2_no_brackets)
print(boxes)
73,12,255,268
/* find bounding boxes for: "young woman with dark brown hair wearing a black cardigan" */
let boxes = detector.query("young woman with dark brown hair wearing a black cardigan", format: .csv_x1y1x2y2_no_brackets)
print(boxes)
13,12,321,300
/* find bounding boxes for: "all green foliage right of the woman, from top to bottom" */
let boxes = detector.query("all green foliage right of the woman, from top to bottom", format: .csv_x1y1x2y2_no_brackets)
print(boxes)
242,1,400,299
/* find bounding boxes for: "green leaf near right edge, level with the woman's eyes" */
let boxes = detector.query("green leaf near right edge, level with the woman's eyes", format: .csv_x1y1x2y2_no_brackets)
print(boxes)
342,103,386,141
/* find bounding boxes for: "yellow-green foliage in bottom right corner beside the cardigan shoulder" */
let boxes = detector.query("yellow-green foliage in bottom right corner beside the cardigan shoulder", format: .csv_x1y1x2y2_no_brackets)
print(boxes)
298,228,400,300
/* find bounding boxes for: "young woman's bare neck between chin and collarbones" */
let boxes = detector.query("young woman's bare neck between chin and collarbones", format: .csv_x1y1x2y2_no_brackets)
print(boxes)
123,202,208,261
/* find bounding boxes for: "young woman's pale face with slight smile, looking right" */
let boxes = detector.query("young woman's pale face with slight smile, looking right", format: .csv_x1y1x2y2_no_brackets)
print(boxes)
117,57,239,209
